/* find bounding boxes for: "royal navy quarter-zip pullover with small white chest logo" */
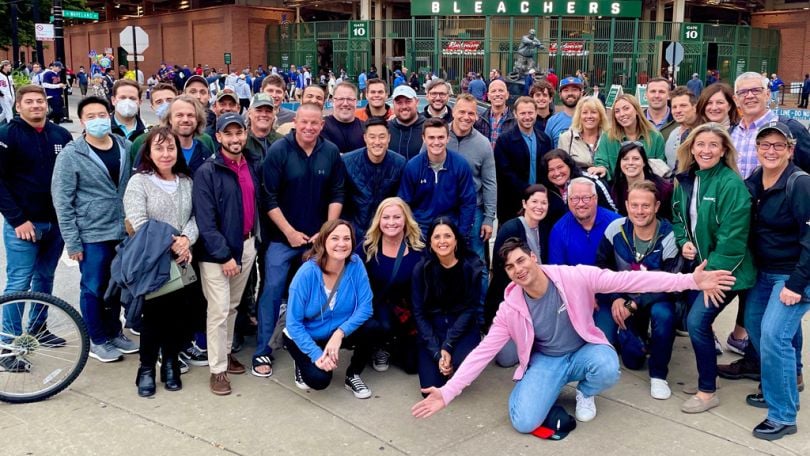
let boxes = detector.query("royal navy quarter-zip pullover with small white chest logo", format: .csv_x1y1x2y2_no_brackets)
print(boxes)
399,150,475,240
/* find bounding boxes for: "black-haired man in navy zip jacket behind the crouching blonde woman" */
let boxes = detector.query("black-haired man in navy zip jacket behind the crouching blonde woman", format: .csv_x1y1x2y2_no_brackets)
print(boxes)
342,117,406,242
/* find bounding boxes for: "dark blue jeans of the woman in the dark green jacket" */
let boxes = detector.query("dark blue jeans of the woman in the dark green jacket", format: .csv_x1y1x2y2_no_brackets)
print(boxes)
686,291,738,393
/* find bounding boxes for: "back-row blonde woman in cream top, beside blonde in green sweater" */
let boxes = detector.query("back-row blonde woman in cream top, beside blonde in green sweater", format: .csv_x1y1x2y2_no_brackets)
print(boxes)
557,97,609,169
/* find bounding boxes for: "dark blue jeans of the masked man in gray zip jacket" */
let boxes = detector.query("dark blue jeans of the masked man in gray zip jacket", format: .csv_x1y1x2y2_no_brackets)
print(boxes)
79,241,121,345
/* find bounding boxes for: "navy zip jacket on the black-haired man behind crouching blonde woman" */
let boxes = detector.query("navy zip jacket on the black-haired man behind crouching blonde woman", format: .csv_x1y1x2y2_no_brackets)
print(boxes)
342,147,407,242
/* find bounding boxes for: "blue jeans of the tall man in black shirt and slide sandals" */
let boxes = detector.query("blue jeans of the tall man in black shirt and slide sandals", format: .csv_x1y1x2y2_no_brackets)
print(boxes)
253,242,307,357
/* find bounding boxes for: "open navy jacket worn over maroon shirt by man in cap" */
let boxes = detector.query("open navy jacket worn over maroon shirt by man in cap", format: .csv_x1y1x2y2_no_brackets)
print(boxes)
191,154,262,266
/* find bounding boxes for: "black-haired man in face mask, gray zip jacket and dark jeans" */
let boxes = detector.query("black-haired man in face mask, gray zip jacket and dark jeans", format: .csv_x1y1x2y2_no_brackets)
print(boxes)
51,97,138,362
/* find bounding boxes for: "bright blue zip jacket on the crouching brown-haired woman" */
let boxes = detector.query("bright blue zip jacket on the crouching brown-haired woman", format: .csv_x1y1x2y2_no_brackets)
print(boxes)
286,253,372,363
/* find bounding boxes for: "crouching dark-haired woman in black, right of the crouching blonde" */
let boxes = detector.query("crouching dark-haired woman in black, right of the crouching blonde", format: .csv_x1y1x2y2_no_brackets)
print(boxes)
411,217,484,388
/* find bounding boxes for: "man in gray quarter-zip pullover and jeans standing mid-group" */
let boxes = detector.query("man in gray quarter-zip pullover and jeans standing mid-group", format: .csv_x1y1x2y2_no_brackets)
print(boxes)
447,93,498,310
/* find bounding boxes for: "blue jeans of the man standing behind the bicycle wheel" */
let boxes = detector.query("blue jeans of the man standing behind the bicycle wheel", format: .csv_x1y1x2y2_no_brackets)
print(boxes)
2,221,65,342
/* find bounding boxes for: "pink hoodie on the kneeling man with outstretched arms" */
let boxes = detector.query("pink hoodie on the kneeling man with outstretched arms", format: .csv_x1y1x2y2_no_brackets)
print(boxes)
440,265,698,404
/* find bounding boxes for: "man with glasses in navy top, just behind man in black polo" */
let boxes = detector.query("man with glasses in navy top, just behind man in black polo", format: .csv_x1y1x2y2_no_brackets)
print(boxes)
321,82,364,154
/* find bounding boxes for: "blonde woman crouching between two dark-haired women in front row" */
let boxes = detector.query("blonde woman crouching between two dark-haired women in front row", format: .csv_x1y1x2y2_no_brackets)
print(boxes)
359,197,425,374
